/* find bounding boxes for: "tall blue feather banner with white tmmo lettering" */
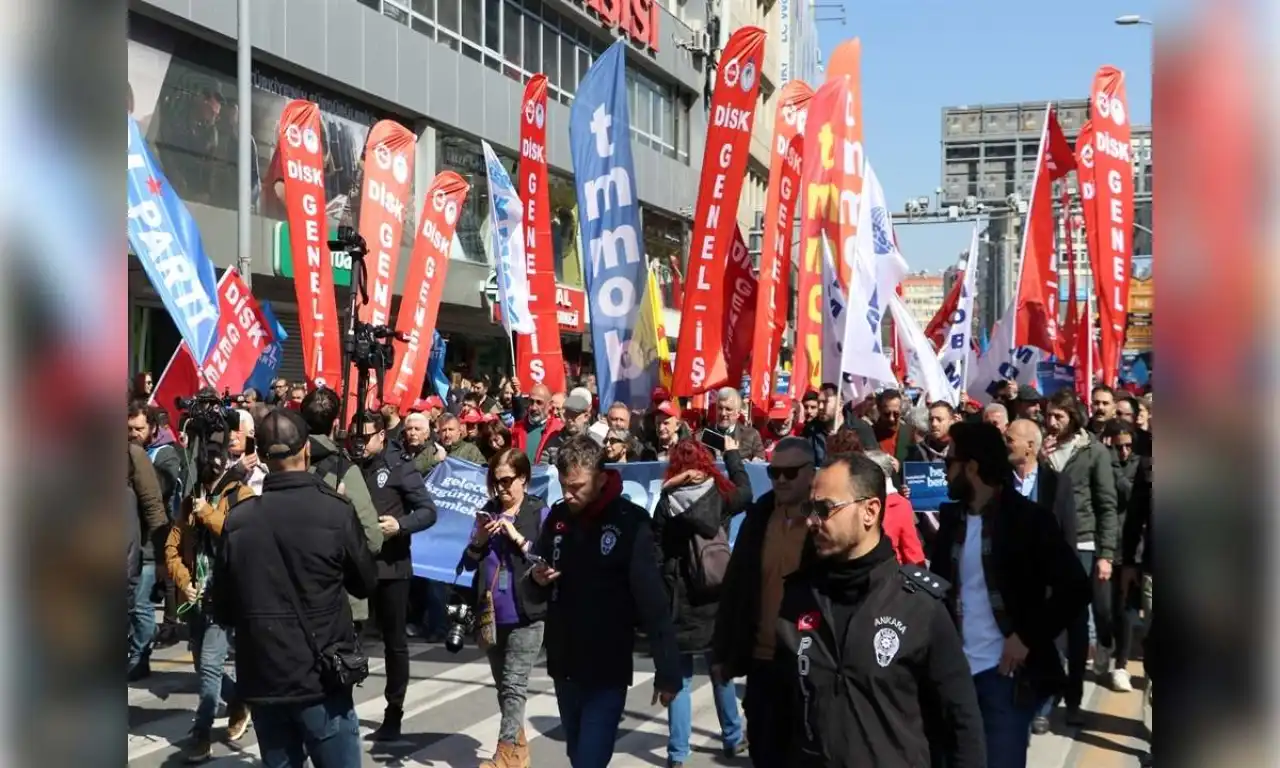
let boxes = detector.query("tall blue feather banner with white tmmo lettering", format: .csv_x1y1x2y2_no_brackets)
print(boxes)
568,40,658,408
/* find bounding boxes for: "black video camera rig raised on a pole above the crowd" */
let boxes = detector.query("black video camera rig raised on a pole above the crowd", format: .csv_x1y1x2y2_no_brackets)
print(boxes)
329,225,408,456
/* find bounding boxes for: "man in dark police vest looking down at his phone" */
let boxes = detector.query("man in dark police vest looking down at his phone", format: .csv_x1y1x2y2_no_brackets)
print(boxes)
530,435,684,768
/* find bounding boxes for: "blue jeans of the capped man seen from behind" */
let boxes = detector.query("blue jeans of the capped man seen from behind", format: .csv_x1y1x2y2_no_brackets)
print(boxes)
250,691,361,768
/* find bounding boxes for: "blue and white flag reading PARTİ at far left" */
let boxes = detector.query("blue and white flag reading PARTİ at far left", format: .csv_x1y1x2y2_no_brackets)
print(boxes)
125,116,218,365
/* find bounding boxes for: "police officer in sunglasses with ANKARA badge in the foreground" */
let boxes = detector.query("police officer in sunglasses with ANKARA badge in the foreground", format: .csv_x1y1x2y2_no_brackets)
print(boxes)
774,453,986,768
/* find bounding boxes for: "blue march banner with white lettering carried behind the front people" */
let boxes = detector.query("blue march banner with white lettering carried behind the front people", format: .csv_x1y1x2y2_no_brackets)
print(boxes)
413,458,768,586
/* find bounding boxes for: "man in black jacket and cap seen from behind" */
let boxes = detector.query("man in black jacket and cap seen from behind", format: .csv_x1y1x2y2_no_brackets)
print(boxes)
209,408,378,767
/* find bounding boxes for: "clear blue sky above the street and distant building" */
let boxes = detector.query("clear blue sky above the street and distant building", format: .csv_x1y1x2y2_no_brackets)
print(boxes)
801,0,1156,271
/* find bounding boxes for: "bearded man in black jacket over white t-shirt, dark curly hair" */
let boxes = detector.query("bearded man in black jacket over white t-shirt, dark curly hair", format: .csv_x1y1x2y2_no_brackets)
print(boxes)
929,422,1091,768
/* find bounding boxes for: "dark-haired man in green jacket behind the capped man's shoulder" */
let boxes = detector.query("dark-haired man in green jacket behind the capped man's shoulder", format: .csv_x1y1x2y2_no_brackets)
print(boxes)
302,387,383,622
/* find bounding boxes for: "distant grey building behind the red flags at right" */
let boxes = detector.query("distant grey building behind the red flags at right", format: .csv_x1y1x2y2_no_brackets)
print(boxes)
940,99,1152,328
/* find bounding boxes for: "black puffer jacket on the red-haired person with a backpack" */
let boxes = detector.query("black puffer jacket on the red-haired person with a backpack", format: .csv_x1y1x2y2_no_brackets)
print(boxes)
653,451,751,653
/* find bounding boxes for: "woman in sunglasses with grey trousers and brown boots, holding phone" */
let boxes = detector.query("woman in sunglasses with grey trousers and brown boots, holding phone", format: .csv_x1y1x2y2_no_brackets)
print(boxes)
461,448,550,768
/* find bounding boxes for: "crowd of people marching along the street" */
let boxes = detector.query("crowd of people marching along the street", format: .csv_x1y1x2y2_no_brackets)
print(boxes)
128,375,1153,768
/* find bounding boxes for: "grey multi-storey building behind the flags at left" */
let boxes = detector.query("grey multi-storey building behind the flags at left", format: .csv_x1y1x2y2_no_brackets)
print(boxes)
128,0,707,386
